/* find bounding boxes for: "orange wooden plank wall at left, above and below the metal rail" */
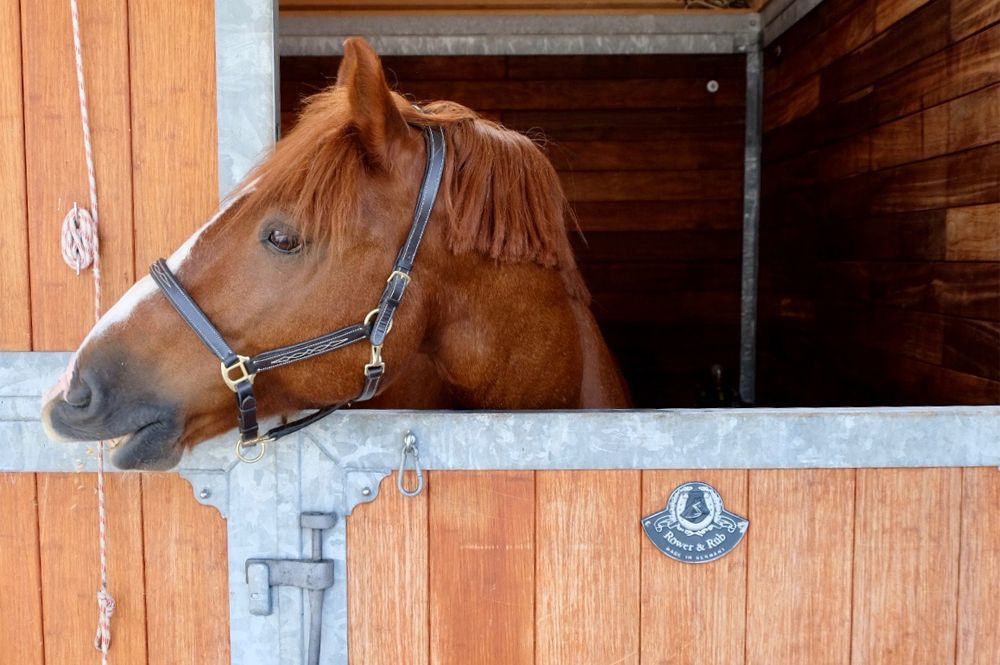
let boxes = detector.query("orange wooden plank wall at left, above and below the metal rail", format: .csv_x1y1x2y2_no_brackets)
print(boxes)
0,0,229,665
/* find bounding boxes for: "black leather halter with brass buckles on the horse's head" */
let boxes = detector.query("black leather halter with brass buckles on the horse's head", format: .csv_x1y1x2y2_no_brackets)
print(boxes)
149,127,445,461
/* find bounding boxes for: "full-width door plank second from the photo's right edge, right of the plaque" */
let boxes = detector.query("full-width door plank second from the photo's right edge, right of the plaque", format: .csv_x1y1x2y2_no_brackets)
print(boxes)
852,469,962,665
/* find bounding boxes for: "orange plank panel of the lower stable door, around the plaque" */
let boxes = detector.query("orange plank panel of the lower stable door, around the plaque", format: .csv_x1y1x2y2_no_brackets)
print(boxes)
348,468,1000,665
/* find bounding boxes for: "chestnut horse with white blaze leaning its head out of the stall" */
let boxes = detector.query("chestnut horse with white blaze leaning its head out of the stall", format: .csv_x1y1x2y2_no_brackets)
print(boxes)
43,39,629,469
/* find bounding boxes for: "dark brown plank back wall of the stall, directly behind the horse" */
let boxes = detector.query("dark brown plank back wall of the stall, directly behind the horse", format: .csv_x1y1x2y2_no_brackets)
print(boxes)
281,56,745,407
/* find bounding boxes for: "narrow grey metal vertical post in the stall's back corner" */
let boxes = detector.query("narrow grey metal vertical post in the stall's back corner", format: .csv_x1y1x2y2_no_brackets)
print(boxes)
740,45,764,404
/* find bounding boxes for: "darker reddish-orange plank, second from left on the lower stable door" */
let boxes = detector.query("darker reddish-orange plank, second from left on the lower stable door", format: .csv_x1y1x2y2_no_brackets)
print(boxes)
432,471,535,665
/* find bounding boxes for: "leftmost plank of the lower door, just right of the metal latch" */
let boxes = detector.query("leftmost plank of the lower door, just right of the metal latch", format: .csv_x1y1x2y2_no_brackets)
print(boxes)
347,472,426,665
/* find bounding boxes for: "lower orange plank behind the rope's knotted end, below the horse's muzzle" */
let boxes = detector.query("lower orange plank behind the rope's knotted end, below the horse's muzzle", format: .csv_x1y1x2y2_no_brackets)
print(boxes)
38,473,147,665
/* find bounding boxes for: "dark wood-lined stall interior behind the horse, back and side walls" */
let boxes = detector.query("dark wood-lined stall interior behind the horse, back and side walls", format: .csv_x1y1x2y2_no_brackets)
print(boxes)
281,0,1000,408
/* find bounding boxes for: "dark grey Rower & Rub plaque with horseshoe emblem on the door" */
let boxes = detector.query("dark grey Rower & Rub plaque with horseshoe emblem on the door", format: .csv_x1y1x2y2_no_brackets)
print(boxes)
642,482,750,563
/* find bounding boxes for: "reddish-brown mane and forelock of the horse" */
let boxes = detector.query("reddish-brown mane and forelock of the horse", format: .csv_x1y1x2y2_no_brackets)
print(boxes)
246,86,590,302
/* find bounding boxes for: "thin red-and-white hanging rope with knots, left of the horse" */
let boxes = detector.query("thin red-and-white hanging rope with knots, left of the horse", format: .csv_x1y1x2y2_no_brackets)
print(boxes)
61,0,115,665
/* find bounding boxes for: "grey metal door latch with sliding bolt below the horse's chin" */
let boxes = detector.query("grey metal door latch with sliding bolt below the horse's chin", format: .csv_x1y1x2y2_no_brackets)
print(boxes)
246,513,337,665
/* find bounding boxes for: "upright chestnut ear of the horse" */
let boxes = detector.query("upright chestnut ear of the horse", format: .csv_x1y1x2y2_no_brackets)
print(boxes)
337,37,407,165
